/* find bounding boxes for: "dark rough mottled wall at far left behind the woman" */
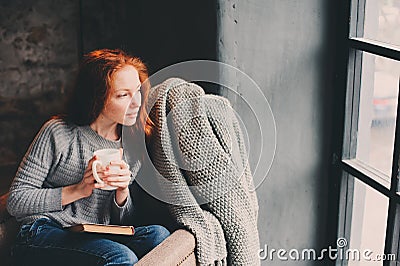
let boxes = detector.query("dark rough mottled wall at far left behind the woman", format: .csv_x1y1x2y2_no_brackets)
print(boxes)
0,0,79,191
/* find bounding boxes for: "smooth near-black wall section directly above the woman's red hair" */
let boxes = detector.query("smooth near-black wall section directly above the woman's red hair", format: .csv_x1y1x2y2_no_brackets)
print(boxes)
81,0,217,74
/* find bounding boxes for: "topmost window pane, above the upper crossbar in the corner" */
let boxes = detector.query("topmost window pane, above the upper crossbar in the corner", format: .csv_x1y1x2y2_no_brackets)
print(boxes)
363,0,400,46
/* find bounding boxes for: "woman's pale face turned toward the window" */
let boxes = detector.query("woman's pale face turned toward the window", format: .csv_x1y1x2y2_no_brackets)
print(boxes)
101,65,142,126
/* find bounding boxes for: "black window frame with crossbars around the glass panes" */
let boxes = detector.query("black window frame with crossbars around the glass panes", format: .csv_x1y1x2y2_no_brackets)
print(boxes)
327,0,400,265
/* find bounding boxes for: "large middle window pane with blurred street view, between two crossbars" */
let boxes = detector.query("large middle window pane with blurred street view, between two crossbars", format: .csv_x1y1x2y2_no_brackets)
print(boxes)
356,52,400,181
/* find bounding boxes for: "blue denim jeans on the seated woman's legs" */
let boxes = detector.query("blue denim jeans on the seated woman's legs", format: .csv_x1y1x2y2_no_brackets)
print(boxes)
13,218,169,266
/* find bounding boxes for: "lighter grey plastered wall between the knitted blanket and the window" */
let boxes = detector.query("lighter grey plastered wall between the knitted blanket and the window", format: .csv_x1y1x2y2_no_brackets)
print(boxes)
218,0,333,265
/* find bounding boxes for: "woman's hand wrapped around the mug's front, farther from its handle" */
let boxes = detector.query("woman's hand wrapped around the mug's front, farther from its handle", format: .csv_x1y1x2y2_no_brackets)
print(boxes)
103,160,131,206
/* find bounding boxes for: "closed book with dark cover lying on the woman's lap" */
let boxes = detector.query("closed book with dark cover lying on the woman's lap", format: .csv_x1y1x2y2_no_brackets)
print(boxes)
67,224,135,235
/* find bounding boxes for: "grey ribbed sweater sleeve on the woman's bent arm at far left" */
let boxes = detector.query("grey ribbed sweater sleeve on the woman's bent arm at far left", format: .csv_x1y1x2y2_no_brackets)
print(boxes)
7,119,65,219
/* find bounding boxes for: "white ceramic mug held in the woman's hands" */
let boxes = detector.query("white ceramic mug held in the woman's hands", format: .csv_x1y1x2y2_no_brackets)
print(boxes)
92,149,121,190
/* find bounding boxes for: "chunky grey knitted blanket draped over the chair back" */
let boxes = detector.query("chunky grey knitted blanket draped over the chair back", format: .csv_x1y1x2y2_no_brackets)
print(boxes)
149,78,260,265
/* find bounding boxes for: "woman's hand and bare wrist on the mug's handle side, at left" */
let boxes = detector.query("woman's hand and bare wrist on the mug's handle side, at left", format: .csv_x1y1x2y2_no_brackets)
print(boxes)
61,156,105,206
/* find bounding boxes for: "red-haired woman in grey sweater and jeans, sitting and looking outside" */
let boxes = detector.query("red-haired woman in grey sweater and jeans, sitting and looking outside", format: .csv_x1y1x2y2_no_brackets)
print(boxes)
8,49,169,265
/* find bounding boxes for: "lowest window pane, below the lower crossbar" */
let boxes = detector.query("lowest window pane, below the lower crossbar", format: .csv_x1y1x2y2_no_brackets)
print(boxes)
348,177,389,266
